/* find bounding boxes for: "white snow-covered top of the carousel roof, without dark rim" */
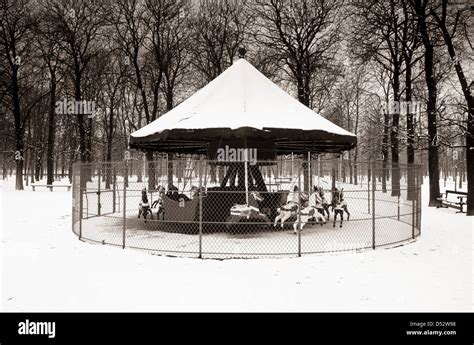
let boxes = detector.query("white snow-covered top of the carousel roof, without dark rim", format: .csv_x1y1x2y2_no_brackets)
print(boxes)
131,59,355,141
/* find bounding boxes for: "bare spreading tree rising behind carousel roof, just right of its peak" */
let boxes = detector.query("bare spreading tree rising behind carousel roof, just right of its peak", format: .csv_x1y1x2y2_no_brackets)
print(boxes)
255,0,341,106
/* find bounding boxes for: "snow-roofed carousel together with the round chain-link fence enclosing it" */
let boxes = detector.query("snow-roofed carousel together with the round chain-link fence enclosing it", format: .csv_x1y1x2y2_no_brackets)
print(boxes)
72,54,422,258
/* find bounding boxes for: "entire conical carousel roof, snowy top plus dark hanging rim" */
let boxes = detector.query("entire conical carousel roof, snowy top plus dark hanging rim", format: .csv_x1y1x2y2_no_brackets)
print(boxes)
130,59,357,152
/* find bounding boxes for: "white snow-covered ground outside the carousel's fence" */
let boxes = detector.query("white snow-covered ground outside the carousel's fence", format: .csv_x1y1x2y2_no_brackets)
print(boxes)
0,179,474,311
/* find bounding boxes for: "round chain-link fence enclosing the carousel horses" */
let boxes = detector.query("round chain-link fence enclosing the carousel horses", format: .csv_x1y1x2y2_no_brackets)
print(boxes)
73,156,421,258
